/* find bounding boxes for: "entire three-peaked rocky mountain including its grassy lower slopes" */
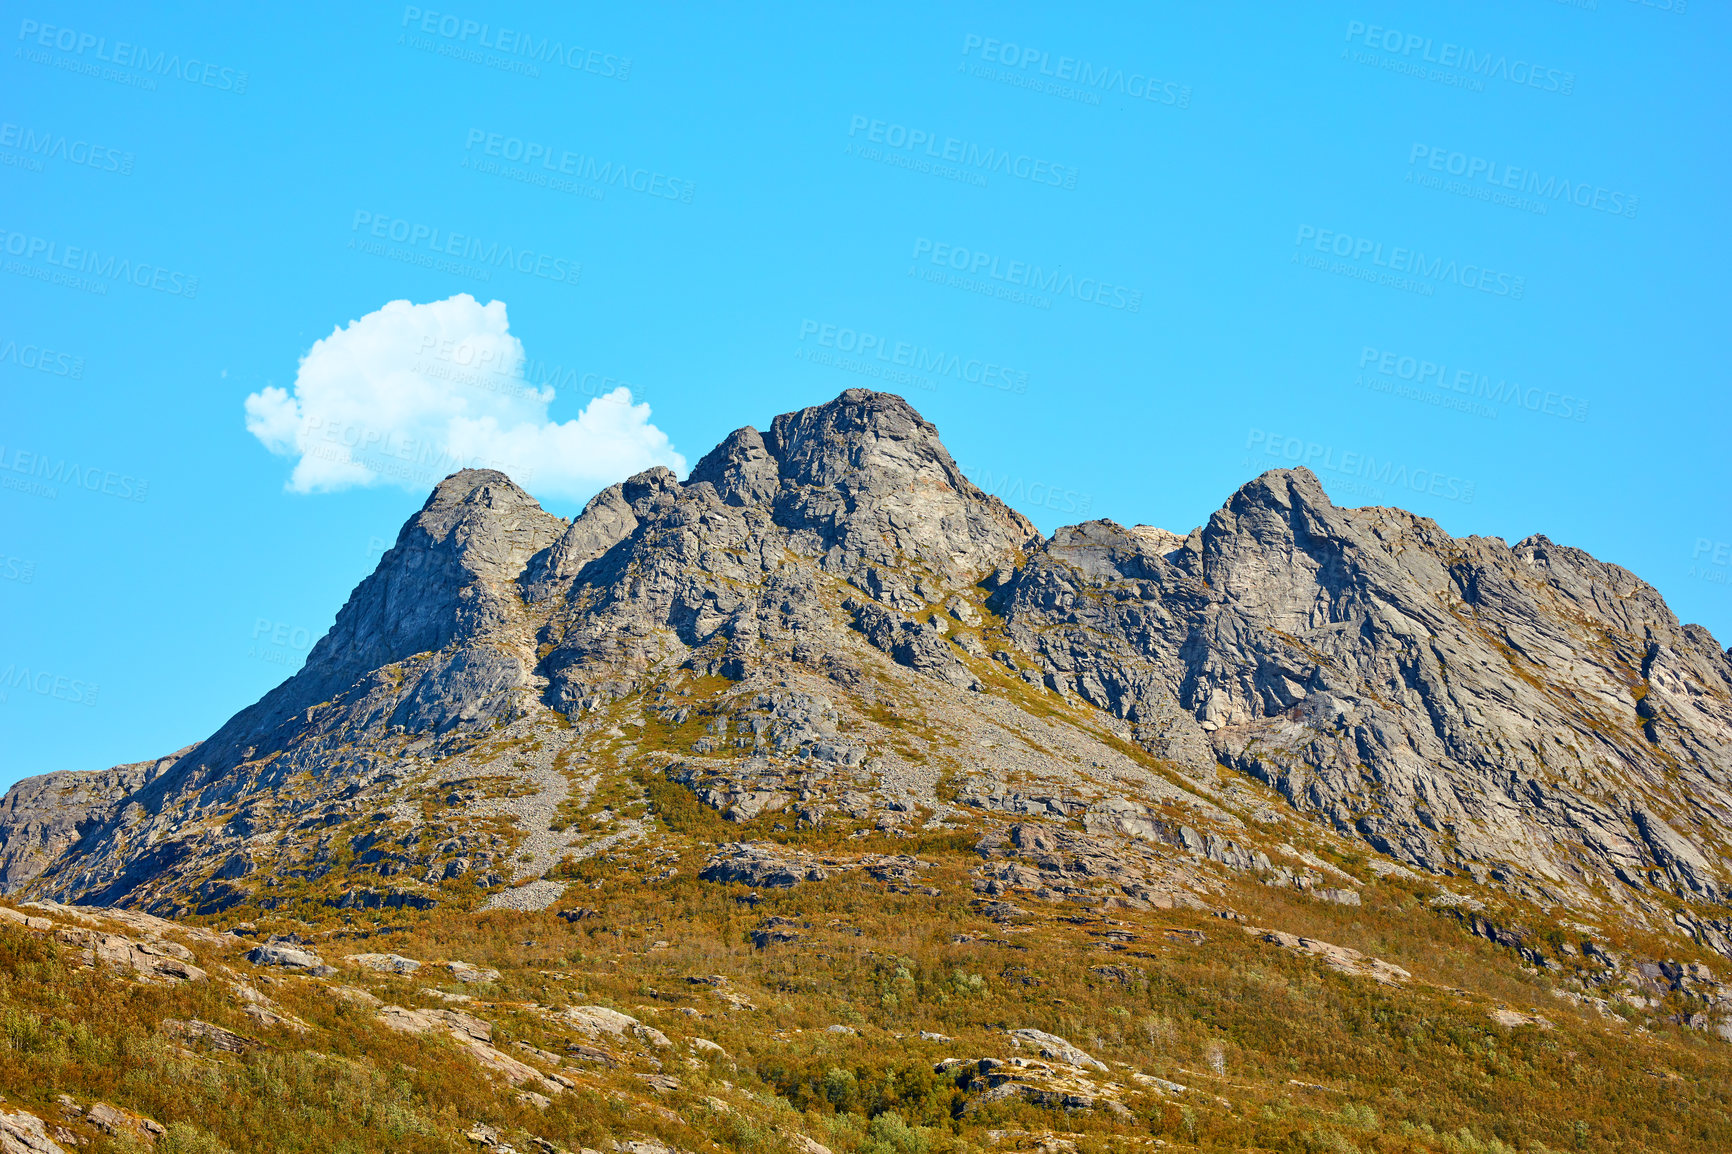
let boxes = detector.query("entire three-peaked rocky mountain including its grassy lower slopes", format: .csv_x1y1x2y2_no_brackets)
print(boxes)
0,390,1732,1154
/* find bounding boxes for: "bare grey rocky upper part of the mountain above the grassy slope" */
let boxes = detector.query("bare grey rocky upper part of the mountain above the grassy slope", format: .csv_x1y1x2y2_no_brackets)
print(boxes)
0,390,1732,955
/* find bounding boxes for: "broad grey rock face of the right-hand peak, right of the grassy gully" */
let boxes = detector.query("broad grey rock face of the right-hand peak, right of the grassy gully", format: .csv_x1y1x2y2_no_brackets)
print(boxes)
999,470,1732,901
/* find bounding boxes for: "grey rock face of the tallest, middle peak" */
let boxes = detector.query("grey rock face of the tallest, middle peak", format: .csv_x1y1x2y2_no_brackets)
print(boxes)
528,390,1036,710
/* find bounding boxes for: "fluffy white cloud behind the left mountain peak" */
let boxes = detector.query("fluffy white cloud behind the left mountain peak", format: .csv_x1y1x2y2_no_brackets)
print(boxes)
246,293,686,501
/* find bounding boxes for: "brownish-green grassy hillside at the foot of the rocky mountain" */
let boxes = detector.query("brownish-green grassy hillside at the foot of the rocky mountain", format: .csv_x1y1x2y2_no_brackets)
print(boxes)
0,800,1732,1154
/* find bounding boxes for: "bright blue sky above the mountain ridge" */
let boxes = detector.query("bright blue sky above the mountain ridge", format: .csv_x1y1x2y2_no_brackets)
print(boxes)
0,0,1732,785
